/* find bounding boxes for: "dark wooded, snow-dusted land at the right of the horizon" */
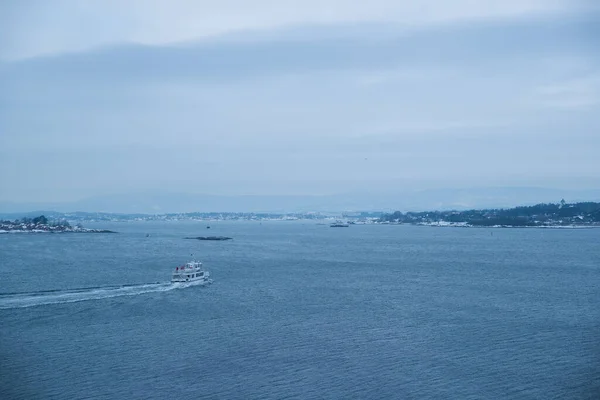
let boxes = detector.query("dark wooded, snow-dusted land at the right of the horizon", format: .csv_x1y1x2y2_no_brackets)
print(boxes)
379,200,600,228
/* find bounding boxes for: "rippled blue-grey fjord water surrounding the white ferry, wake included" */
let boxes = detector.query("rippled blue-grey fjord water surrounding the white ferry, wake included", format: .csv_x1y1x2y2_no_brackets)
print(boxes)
0,221,600,399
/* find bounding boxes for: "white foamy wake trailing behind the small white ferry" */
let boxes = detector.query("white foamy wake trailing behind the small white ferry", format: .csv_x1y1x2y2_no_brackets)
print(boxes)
0,282,211,310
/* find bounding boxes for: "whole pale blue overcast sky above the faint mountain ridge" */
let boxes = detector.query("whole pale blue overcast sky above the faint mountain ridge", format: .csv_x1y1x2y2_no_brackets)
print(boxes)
0,0,600,202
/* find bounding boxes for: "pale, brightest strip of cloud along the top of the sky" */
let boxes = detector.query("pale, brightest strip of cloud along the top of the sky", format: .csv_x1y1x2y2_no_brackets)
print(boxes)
0,0,580,59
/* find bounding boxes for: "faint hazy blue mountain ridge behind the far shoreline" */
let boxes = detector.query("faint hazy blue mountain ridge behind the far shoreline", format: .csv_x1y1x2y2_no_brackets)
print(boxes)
0,187,600,214
